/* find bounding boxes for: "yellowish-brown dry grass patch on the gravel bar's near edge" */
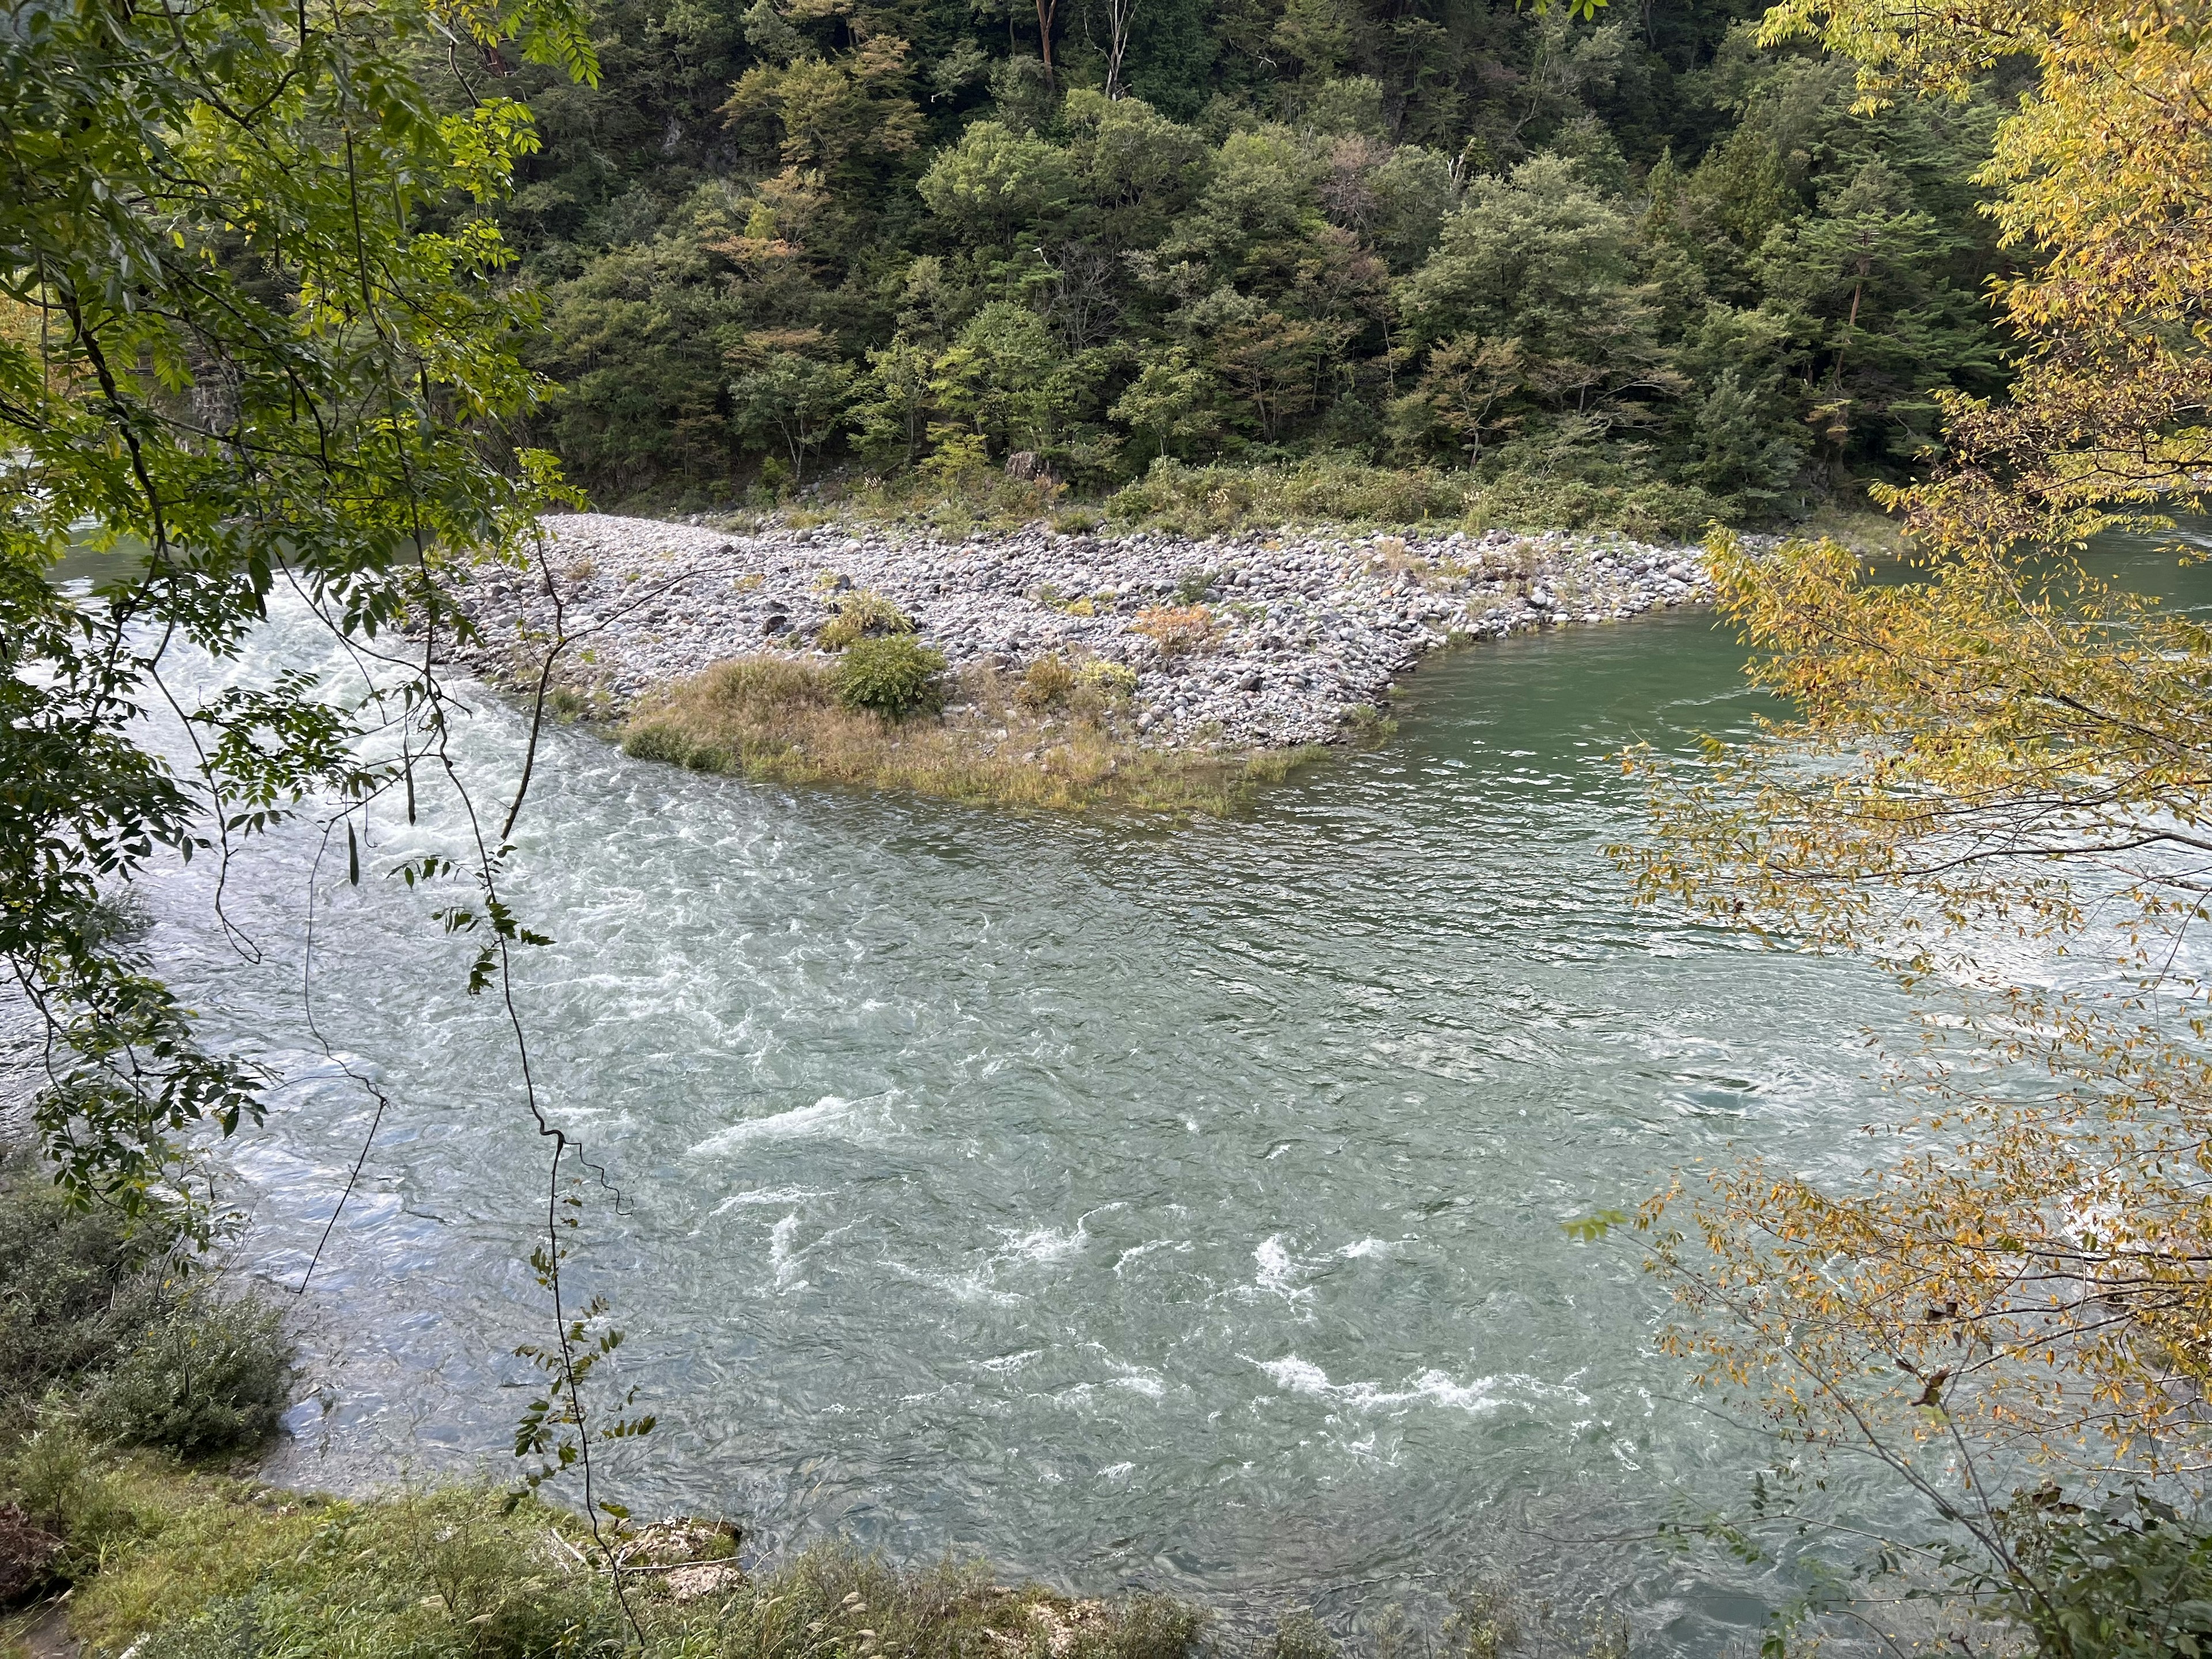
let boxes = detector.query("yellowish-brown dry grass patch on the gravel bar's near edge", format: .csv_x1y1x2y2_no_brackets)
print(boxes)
622,657,1327,816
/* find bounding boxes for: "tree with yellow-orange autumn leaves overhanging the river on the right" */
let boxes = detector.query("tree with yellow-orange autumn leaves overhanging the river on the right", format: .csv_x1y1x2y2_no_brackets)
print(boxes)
1619,0,2212,1654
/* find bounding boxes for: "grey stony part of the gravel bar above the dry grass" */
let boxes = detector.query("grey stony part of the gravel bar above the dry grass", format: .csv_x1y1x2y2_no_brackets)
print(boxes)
458,513,1712,748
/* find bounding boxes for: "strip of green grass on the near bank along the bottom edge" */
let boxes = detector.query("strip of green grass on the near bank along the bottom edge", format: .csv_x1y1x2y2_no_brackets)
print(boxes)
26,1467,1201,1659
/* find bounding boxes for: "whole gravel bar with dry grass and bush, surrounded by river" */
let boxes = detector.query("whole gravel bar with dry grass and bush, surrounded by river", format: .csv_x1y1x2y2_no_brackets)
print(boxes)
456,513,1743,814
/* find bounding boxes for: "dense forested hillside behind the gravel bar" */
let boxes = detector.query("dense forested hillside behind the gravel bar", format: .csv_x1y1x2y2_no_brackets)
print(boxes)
463,0,2004,529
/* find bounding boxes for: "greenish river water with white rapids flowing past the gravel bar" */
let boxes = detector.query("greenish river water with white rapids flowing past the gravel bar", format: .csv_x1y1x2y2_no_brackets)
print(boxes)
78,535,2203,1652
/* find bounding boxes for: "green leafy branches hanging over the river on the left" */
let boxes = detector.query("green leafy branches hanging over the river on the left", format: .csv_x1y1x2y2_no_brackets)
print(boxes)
0,0,642,1601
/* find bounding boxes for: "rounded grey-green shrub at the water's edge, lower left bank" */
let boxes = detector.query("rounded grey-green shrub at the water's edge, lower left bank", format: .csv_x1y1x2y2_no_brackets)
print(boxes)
86,1290,292,1458
